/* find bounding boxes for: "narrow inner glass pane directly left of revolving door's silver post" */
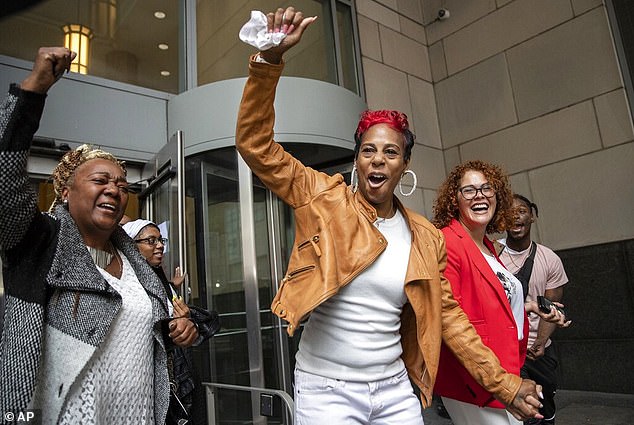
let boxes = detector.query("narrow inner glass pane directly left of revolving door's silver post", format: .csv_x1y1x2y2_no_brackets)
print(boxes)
202,167,252,423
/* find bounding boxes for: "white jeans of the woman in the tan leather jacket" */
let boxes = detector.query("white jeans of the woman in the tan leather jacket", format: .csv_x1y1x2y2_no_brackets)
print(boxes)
294,369,423,425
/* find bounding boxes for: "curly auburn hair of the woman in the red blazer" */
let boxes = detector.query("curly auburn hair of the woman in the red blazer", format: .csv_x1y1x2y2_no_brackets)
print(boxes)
432,160,513,233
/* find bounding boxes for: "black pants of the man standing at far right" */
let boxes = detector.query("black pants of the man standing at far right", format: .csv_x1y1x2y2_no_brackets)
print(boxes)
520,344,558,425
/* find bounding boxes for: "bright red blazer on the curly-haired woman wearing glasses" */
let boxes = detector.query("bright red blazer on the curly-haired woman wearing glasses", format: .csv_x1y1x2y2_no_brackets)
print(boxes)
434,219,528,408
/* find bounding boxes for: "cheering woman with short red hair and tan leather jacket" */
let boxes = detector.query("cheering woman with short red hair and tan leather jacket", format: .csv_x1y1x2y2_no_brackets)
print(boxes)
236,7,539,424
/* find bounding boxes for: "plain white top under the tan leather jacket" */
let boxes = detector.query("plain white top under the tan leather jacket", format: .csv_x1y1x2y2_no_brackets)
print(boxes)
296,211,411,382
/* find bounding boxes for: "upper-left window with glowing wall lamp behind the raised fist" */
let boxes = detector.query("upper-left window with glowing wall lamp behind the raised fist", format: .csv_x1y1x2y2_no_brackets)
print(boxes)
0,0,180,93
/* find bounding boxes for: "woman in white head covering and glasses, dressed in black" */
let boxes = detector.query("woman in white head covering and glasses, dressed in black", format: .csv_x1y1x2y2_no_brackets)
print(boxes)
122,219,220,425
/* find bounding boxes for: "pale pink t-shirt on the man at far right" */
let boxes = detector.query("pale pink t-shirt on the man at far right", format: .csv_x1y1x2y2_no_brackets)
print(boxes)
498,239,568,347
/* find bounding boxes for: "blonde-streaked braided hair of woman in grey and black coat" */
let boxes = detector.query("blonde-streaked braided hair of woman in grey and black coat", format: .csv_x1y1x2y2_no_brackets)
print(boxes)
49,145,127,211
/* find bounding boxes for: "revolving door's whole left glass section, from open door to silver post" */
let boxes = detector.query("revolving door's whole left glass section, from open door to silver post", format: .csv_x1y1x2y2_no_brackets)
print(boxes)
186,147,257,424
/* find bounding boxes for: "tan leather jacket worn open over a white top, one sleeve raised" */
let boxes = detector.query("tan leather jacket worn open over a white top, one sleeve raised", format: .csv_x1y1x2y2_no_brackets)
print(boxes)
236,54,521,407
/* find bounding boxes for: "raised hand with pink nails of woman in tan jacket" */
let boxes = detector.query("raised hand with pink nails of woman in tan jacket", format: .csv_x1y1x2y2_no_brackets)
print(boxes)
260,6,317,64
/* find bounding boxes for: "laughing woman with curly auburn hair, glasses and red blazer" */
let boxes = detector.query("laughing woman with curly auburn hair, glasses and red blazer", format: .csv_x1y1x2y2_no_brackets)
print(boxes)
433,160,567,425
